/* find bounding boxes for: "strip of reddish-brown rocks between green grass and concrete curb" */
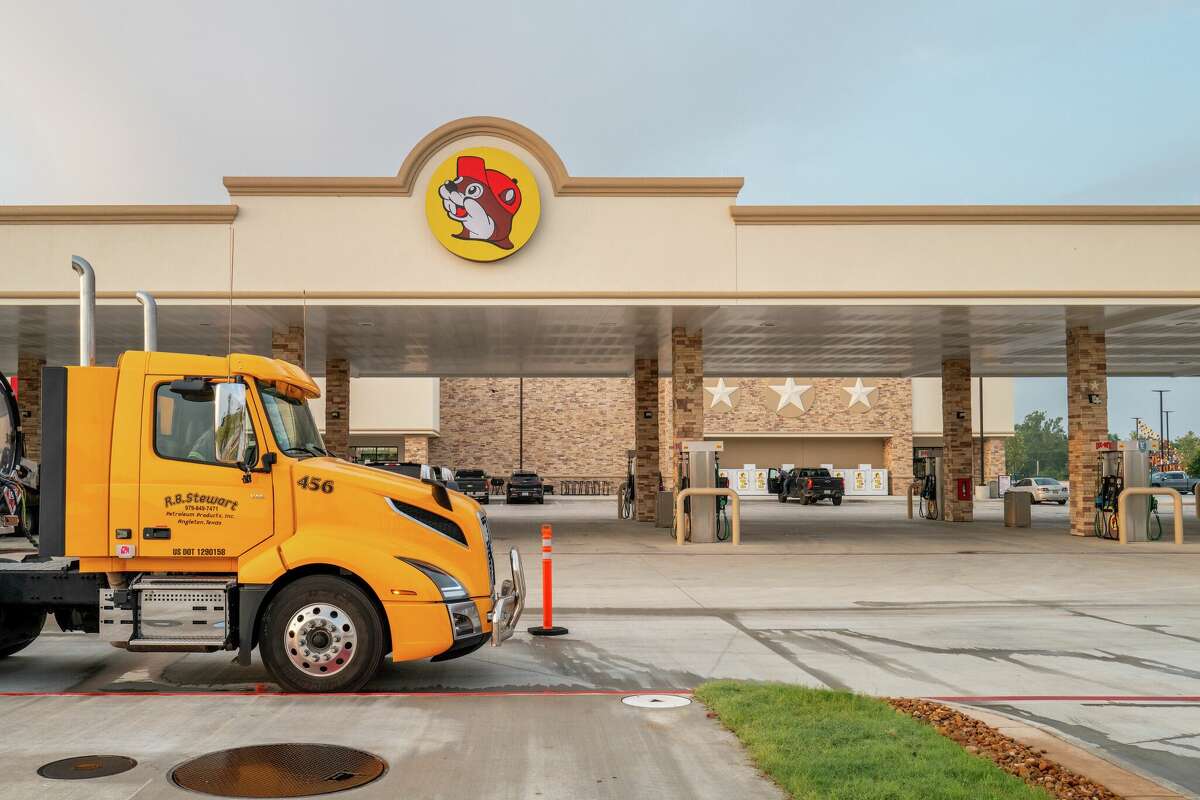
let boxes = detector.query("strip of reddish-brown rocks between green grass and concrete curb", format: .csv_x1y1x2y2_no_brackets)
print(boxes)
888,698,1121,800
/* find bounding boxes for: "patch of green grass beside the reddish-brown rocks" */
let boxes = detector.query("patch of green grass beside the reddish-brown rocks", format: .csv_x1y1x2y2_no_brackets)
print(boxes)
696,680,1050,800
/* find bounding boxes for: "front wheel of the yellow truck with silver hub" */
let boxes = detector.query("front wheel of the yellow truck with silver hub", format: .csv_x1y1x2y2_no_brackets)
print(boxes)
258,575,384,692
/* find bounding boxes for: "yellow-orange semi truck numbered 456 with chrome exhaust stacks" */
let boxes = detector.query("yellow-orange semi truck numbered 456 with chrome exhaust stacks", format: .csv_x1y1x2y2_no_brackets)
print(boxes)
0,257,526,692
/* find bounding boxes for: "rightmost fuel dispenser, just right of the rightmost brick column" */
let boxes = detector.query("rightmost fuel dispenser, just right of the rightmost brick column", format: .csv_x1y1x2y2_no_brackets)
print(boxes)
1092,439,1151,542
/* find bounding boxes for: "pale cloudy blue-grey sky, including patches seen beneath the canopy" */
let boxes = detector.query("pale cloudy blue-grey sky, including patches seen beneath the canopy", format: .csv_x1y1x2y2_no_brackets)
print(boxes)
0,0,1200,431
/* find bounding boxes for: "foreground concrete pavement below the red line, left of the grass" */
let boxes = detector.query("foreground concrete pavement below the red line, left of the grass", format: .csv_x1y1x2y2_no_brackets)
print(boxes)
0,696,784,800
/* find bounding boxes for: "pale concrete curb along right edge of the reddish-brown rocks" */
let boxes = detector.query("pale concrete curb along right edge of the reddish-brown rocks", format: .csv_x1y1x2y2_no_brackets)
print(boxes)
944,703,1190,800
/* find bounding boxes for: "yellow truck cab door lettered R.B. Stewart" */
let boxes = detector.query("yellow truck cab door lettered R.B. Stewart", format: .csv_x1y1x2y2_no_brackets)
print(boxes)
136,375,275,569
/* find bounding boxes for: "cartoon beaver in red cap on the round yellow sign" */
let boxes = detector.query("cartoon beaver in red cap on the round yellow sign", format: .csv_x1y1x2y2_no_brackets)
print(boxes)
438,156,521,249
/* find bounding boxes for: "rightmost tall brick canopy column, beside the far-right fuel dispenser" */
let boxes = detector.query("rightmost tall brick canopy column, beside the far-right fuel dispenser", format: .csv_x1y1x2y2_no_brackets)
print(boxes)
1067,326,1109,536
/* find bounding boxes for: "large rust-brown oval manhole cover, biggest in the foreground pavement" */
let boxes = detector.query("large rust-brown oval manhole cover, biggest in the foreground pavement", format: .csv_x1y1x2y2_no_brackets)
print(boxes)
170,745,388,798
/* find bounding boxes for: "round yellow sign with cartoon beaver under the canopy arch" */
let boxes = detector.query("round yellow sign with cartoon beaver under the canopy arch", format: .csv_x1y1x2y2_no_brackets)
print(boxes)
425,148,541,261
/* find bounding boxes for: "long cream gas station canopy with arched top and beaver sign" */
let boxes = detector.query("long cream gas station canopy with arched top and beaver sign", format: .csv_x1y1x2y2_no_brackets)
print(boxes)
0,118,1200,377
